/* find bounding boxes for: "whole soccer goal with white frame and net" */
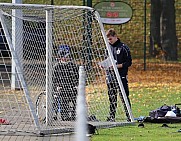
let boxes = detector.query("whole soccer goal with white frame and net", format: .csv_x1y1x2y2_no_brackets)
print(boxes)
0,3,133,134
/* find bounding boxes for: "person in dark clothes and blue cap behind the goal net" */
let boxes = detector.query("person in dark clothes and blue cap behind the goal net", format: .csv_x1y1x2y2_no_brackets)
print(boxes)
53,45,79,121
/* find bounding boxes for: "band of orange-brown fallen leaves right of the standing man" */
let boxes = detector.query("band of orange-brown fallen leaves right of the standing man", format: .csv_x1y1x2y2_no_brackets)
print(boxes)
129,60,181,85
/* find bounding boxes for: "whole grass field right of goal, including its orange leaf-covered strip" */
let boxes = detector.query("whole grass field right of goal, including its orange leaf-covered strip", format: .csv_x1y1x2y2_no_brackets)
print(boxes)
91,62,181,141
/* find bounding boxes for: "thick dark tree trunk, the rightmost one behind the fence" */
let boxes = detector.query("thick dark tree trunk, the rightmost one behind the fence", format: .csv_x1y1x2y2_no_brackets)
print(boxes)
160,0,178,61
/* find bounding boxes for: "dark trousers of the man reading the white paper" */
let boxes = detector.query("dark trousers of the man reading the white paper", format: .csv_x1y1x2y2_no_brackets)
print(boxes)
107,77,131,119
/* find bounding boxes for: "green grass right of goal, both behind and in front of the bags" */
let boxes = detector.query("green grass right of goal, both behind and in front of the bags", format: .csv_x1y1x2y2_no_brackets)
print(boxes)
91,84,181,141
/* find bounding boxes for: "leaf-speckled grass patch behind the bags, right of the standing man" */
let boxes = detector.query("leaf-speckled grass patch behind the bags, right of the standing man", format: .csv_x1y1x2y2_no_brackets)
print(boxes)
130,86,181,117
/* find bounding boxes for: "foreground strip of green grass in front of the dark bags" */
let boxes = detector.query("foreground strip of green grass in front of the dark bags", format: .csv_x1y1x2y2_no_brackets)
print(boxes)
91,123,181,141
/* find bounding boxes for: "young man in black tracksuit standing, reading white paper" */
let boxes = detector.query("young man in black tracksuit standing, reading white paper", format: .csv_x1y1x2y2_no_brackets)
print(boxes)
106,29,132,121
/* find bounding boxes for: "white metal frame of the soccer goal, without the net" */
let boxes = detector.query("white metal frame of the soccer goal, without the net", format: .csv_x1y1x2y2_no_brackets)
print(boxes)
0,3,134,134
